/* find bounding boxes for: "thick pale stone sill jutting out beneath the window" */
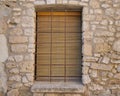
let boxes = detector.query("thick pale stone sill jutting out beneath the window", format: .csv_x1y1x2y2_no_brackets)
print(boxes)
31,82,85,93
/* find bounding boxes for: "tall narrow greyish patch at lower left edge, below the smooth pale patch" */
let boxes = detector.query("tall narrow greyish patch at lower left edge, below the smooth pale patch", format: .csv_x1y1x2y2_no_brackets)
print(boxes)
0,62,7,93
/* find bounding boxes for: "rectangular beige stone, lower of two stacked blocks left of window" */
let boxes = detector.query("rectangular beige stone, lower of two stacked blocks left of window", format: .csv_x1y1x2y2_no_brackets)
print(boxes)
11,44,27,53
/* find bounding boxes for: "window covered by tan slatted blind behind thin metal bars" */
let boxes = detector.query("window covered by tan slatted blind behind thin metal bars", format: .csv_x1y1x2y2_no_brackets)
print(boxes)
35,11,82,81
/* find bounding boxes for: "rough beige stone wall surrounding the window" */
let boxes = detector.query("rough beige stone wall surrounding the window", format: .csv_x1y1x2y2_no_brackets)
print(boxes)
0,0,120,96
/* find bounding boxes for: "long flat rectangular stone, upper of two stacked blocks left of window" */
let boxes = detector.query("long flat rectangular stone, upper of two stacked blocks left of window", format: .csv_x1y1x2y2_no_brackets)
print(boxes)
9,36,28,44
